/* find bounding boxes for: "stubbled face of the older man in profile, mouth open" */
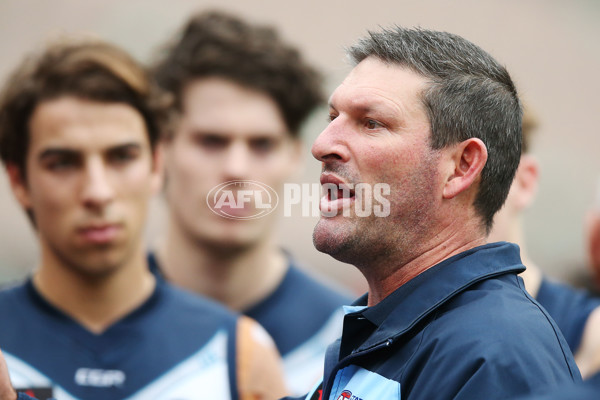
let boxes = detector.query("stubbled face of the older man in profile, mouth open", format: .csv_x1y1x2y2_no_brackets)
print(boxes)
312,58,442,264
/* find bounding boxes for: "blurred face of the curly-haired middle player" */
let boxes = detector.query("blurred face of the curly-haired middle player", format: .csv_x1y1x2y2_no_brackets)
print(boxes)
164,78,300,249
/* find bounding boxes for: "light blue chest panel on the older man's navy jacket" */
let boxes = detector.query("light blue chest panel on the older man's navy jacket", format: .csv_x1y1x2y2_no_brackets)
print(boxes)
328,365,402,400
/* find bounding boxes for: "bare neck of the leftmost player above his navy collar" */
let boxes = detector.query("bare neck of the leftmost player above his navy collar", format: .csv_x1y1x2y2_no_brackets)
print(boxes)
33,244,156,333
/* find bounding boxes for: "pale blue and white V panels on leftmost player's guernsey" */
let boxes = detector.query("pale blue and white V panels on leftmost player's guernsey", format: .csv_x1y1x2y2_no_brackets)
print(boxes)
4,330,231,400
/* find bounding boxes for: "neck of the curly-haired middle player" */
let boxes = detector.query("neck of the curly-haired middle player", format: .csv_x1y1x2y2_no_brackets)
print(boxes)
156,223,288,312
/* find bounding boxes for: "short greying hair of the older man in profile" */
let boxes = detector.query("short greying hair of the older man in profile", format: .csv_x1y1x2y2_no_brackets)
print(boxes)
347,26,522,232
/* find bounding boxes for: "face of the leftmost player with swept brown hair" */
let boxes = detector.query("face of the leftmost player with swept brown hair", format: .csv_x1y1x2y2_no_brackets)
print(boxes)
11,96,160,276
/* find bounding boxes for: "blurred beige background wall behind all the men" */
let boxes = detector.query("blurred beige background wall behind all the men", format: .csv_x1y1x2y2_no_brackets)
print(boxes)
0,0,600,291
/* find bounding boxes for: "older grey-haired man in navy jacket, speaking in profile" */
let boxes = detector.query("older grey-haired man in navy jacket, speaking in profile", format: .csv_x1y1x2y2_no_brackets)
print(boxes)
292,27,581,400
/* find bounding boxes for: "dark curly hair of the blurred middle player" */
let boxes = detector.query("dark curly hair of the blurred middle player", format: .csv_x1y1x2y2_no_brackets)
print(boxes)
153,11,323,136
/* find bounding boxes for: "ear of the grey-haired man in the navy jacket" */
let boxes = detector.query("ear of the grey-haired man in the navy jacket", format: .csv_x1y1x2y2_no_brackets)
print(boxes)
443,138,487,199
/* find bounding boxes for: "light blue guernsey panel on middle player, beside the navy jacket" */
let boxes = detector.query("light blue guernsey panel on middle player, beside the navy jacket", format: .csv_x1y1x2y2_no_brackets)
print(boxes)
283,307,344,393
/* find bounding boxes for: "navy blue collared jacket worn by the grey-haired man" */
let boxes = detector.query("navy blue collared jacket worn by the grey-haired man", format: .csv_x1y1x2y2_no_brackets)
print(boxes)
306,243,581,400
